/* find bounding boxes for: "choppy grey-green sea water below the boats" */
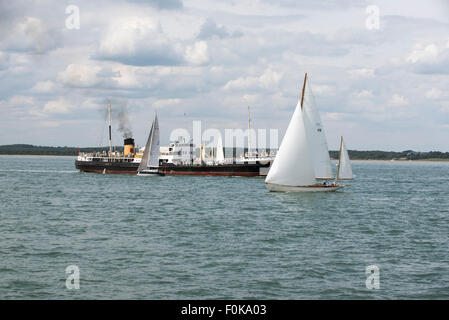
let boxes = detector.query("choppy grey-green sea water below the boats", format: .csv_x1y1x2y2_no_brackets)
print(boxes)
0,156,449,299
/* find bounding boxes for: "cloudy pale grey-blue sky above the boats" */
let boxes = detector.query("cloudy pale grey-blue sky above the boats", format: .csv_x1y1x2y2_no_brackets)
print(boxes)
0,0,449,151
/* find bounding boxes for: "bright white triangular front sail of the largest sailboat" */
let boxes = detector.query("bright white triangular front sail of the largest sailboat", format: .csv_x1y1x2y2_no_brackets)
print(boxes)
265,102,316,186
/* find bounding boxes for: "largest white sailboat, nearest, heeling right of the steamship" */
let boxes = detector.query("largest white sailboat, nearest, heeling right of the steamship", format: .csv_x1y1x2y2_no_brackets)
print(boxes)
265,74,344,192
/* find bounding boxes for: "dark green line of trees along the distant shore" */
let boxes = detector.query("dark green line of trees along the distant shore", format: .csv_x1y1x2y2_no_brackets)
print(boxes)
0,144,449,160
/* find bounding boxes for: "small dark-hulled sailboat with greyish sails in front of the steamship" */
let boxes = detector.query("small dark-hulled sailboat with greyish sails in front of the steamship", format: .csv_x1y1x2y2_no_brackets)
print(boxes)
137,114,165,176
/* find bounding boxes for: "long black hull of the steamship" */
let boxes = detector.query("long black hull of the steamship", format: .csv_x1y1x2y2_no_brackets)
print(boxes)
75,160,270,177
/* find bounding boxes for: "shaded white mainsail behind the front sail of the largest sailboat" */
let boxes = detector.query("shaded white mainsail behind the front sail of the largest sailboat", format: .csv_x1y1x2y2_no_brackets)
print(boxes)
302,79,334,179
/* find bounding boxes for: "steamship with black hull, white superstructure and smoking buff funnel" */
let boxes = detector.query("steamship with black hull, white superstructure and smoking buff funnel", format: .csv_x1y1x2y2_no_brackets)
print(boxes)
75,104,275,177
